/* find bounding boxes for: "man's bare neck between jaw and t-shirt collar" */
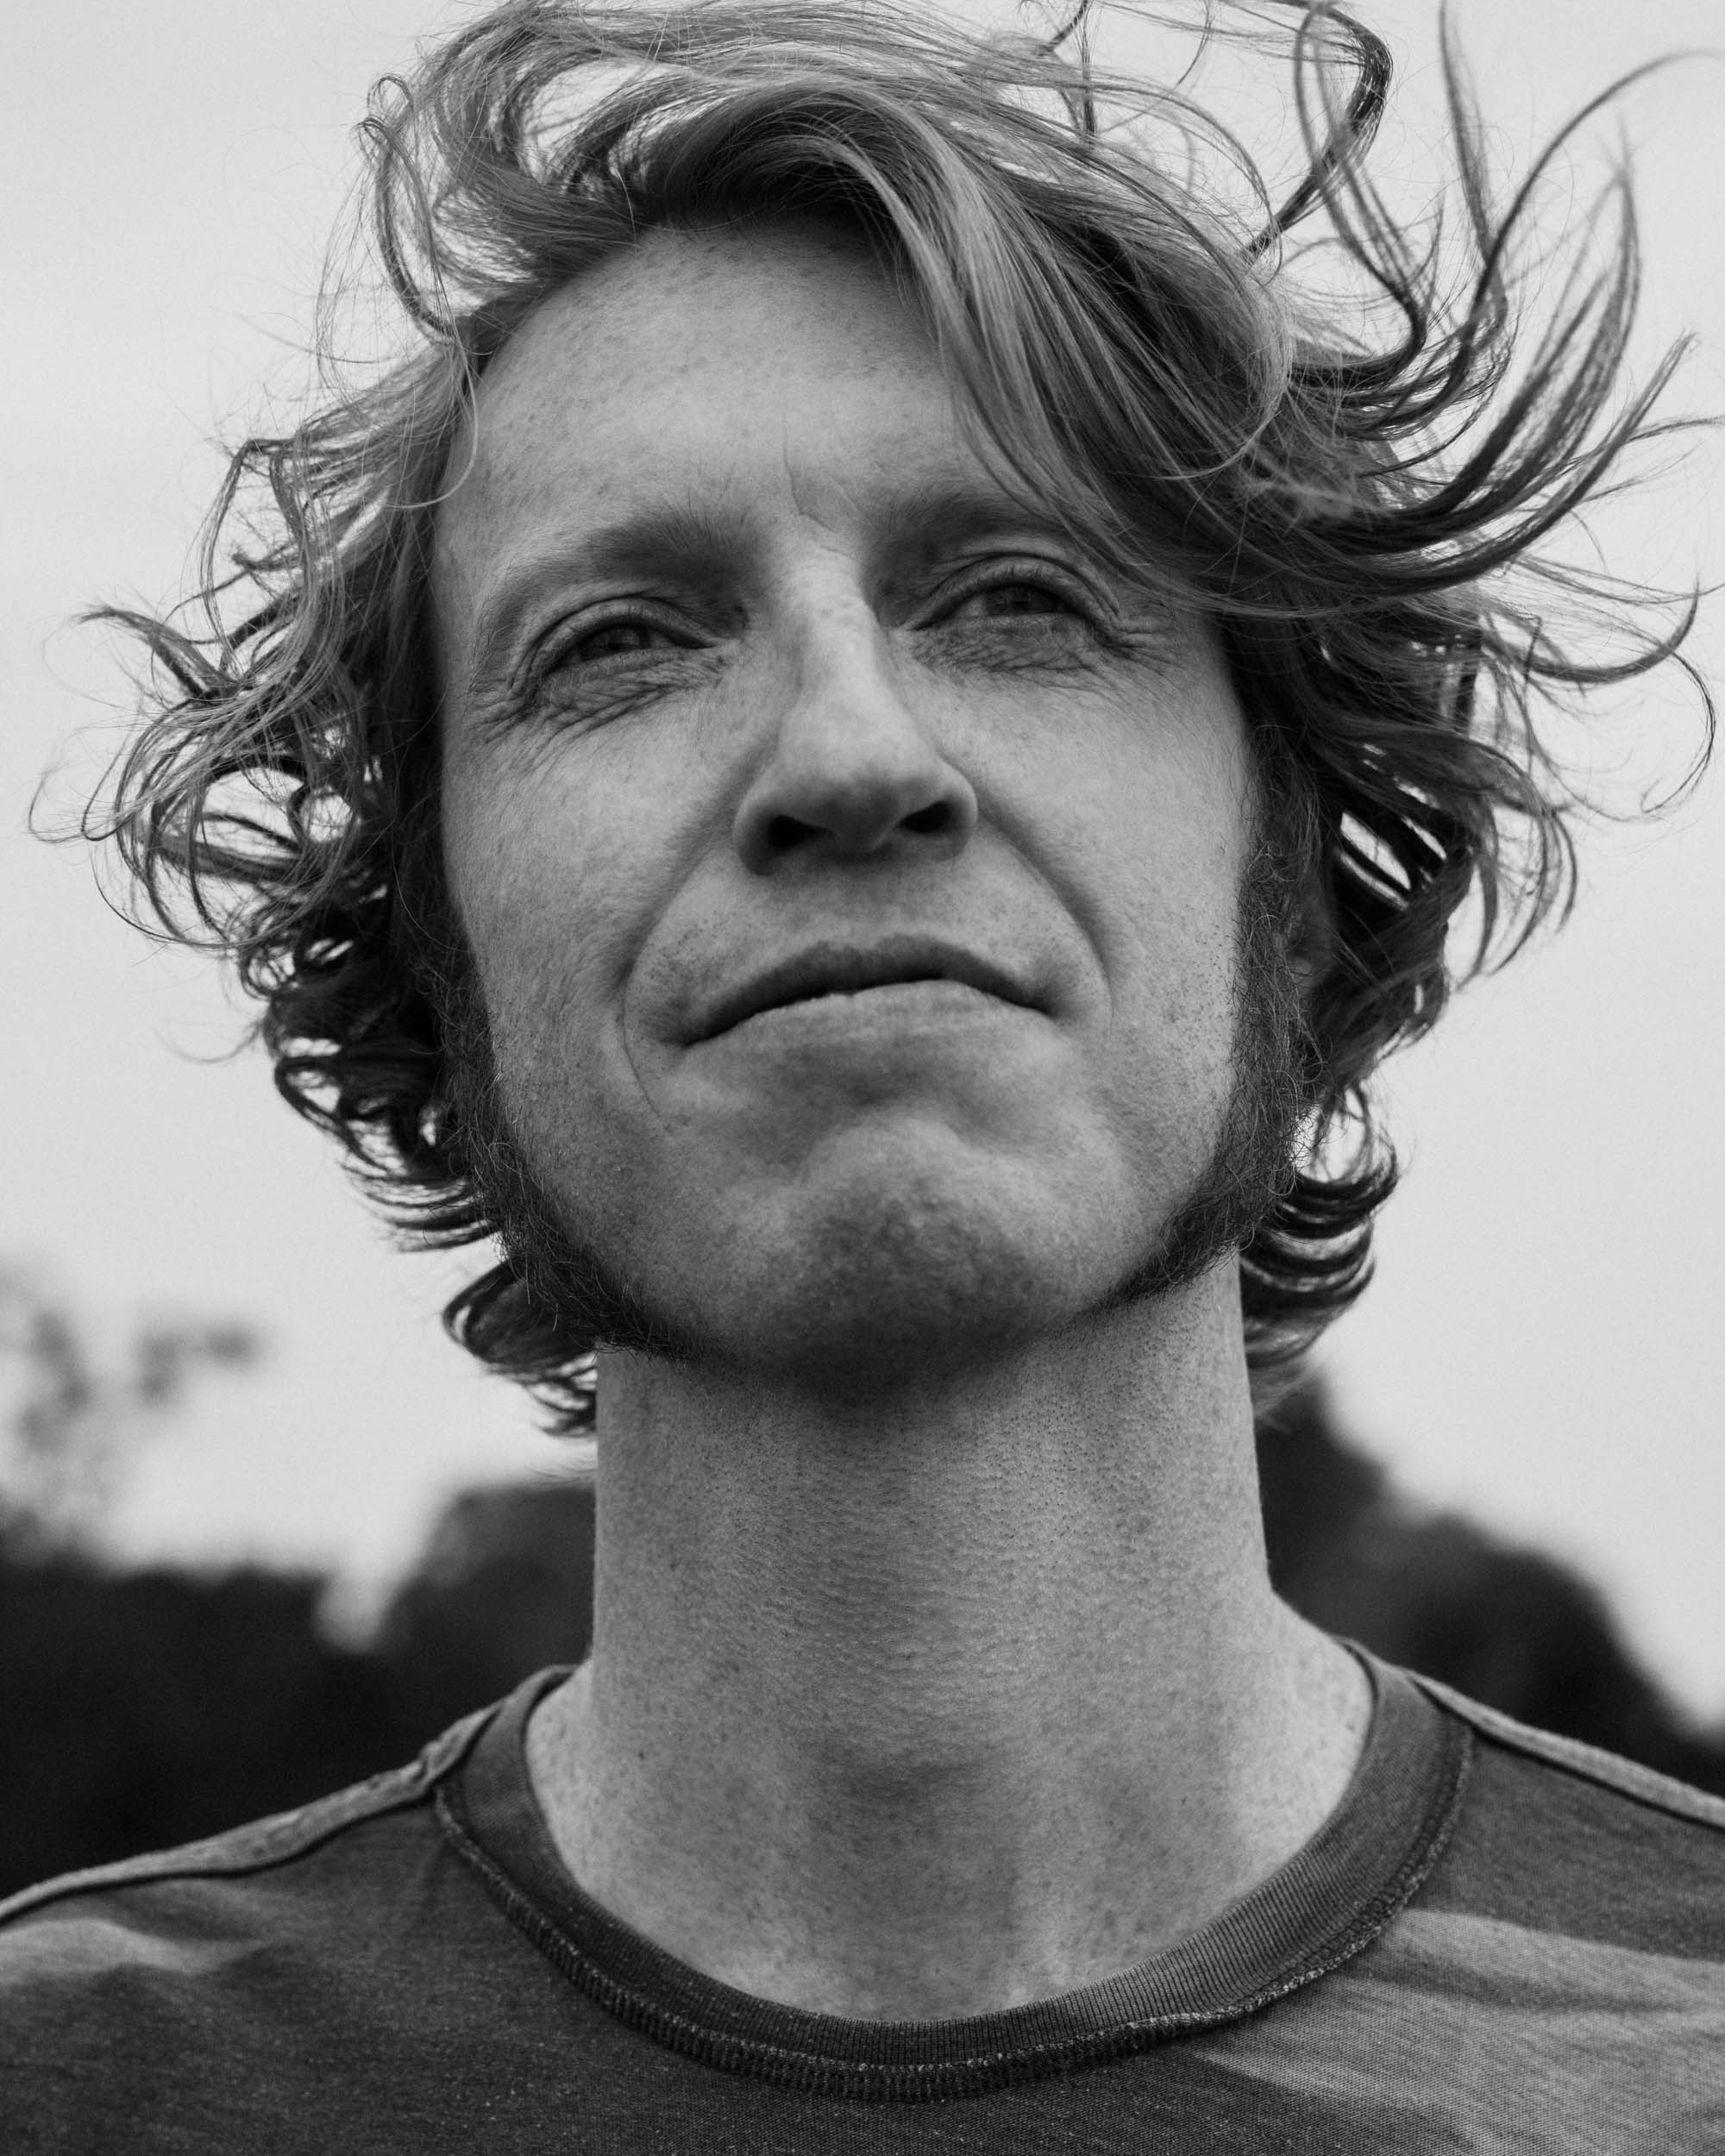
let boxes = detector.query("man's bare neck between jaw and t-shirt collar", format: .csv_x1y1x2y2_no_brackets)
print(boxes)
529,1270,1365,2021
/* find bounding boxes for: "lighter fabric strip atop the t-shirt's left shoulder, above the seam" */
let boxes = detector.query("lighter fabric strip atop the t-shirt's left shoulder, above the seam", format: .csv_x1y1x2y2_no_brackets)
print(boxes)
0,1706,499,1926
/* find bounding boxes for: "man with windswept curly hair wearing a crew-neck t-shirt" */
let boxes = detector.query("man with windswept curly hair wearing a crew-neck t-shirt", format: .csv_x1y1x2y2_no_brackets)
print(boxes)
0,4,1725,2152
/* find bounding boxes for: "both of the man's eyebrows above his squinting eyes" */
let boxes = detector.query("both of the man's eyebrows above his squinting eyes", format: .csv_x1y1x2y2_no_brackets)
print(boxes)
466,481,1068,693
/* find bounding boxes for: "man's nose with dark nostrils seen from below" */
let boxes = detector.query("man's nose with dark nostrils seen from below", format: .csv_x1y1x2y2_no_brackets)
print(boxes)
736,621,977,875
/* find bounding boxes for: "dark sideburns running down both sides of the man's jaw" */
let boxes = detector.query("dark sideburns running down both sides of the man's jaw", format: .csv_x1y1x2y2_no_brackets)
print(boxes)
436,843,1309,1367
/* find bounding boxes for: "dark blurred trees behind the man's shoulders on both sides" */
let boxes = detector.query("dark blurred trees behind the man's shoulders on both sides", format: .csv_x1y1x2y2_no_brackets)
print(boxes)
0,1276,1725,1893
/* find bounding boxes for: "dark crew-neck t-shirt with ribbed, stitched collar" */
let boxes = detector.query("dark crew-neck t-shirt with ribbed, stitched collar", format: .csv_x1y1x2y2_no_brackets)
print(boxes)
0,1663,1725,2156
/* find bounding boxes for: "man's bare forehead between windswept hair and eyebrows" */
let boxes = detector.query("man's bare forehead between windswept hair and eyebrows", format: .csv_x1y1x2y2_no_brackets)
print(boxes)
438,233,1070,647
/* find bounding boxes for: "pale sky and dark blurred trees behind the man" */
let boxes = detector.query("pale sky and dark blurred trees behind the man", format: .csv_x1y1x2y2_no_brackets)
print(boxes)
0,0,1725,1889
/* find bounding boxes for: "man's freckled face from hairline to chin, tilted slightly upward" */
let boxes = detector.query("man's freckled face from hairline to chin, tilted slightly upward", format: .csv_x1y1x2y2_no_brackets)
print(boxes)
434,227,1253,1382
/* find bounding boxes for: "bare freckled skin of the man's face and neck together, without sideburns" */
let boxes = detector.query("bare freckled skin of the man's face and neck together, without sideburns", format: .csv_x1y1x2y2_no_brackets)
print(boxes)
434,227,1365,2018
